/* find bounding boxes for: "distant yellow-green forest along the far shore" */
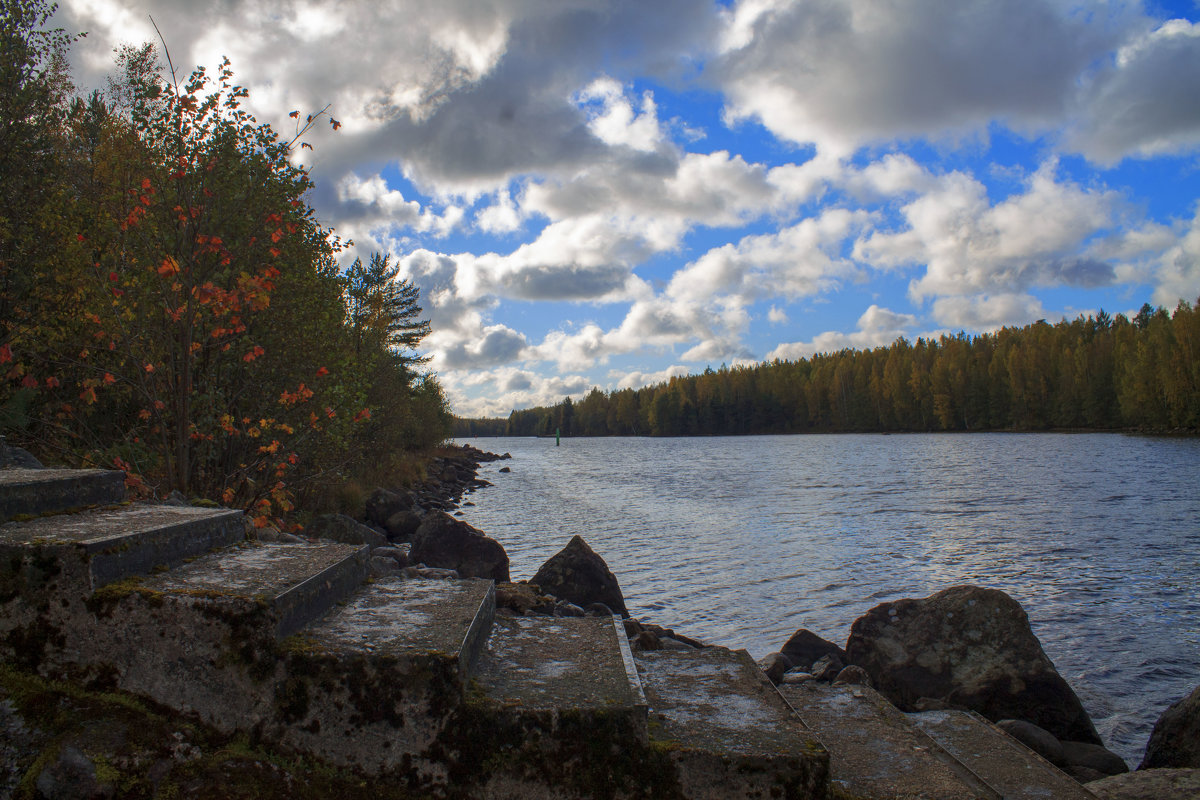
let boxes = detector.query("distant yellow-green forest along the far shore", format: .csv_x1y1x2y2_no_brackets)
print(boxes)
455,300,1200,437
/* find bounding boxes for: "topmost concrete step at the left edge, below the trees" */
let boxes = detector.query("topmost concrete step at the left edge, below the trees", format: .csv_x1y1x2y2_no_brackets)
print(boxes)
0,469,125,522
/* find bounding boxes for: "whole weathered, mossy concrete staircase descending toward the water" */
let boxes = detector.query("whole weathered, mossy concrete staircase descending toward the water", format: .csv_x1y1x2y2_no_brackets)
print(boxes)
0,469,1092,800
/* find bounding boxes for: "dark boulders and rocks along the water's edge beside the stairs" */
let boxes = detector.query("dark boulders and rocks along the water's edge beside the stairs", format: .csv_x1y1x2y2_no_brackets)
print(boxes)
306,445,1200,800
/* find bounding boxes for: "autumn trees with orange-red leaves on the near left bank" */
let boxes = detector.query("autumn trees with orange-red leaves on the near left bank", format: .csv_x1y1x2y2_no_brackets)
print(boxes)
0,0,451,522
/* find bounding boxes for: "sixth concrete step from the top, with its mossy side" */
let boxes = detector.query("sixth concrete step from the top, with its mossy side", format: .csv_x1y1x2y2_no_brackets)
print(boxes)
635,648,829,800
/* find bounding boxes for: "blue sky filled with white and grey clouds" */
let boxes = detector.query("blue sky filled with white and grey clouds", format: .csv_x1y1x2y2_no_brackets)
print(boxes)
55,0,1200,416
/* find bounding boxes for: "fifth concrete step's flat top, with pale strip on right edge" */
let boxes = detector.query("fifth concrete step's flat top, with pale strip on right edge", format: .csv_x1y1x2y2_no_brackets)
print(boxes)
475,616,646,718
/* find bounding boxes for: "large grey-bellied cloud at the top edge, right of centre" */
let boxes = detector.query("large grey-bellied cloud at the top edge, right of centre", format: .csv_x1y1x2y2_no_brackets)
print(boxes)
710,0,1117,154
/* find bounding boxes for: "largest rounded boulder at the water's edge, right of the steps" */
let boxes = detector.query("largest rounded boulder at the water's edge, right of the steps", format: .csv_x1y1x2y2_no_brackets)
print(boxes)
846,587,1103,745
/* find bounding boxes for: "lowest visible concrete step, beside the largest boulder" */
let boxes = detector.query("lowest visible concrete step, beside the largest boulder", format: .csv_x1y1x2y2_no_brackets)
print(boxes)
907,711,1096,800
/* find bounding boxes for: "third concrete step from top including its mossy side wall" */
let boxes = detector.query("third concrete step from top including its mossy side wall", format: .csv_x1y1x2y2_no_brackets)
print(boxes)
43,542,370,733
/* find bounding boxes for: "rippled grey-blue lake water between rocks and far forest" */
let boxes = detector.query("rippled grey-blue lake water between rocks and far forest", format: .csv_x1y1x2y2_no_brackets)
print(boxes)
453,434,1200,765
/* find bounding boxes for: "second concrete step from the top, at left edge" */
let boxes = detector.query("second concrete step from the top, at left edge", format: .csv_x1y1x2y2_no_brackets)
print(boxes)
0,506,246,589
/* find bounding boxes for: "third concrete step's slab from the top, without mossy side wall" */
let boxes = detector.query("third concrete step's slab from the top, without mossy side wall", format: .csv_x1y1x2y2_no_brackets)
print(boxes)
139,542,371,636
